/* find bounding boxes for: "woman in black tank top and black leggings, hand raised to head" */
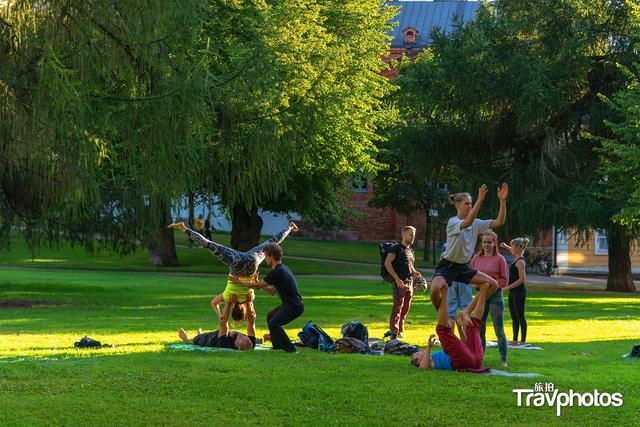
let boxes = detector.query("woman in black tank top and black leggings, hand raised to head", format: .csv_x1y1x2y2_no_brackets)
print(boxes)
502,237,529,345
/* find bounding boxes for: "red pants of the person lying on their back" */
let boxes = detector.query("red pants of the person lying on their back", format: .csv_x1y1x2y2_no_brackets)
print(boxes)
436,317,484,369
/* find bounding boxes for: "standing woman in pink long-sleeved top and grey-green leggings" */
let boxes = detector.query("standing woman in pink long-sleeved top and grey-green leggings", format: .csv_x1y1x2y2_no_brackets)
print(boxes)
470,230,509,368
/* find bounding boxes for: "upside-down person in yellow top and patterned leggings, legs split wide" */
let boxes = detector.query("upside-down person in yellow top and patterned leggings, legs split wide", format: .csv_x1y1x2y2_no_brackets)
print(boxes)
167,222,298,336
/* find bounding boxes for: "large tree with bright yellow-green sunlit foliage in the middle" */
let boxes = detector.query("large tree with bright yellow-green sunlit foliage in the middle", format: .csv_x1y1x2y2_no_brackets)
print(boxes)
203,0,393,249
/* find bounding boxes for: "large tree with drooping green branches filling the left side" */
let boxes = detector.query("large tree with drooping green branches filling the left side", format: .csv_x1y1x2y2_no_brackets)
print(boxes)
0,0,210,265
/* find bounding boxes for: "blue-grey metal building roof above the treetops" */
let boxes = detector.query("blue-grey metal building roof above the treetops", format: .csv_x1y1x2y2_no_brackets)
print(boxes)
385,1,479,48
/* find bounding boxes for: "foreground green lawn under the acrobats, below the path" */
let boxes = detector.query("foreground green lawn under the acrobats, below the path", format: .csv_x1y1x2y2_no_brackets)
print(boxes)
0,270,640,426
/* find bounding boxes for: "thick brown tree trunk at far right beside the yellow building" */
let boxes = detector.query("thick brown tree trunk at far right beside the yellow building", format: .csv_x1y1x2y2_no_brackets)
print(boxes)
607,224,636,292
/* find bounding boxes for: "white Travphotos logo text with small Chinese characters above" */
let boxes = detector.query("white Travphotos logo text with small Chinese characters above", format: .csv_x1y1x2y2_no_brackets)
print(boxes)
513,383,624,417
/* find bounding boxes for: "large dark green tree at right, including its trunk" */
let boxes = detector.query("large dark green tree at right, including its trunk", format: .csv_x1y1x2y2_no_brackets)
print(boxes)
388,0,635,290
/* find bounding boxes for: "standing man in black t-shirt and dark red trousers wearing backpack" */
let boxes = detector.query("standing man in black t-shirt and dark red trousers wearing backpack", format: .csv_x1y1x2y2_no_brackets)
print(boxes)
384,225,422,338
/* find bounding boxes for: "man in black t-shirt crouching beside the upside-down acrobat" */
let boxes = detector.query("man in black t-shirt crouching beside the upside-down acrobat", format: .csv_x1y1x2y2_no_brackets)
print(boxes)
230,243,304,353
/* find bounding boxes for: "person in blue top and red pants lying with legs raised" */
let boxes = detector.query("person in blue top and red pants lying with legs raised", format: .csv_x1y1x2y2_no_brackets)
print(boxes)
411,283,497,371
